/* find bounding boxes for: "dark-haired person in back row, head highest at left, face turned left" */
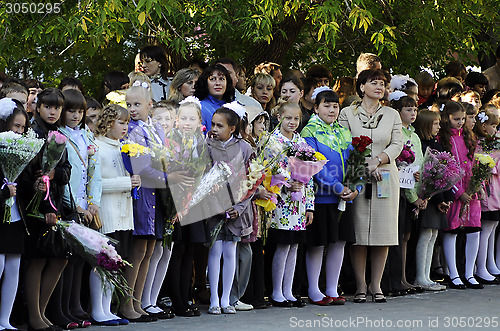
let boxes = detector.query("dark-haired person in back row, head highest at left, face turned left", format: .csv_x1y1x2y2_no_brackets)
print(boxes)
140,45,172,101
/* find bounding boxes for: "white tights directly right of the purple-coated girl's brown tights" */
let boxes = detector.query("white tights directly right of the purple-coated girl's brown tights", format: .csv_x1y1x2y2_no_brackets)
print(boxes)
141,240,172,313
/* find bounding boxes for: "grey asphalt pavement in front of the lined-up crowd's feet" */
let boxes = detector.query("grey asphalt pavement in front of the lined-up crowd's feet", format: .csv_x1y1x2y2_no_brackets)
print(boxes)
80,285,500,331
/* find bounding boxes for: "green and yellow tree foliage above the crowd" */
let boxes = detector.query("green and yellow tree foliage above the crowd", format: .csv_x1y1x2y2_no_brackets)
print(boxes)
0,0,500,92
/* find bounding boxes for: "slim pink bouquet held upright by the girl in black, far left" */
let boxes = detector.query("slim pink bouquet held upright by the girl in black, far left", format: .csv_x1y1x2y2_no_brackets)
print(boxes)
27,131,68,219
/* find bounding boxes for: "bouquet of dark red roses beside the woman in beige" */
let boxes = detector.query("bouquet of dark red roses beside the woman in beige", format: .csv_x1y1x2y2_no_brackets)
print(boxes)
339,136,373,211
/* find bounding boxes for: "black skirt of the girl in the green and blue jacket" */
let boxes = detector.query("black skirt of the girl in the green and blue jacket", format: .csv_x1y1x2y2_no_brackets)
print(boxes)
306,203,356,246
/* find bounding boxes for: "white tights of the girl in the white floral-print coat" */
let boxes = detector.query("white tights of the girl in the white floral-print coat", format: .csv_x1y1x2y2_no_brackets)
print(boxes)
272,244,299,302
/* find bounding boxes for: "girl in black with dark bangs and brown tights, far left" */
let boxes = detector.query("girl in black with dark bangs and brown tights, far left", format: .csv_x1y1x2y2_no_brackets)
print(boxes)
18,88,71,330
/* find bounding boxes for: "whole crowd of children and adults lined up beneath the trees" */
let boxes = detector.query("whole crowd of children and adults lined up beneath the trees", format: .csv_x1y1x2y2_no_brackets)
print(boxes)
0,46,500,330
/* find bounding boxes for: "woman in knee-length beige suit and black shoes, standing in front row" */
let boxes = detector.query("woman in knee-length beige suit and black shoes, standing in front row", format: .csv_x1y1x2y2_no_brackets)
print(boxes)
339,70,403,303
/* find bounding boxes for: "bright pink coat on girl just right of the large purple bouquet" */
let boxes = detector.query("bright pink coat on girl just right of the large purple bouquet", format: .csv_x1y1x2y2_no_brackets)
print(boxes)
446,129,481,230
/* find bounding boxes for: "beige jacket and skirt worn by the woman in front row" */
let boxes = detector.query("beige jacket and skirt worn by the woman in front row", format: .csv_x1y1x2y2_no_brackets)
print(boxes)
339,105,403,246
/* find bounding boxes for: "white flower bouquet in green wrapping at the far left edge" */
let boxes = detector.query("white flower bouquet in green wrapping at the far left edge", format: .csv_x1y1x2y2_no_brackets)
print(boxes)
0,130,45,223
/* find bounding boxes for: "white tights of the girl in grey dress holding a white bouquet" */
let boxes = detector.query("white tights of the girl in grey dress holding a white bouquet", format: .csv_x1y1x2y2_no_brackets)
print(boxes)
208,240,237,307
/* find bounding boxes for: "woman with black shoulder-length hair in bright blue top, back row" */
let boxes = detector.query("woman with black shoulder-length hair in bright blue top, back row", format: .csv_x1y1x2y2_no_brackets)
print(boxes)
194,64,234,132
